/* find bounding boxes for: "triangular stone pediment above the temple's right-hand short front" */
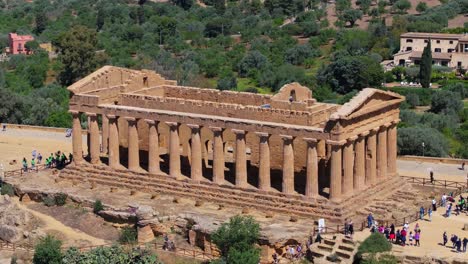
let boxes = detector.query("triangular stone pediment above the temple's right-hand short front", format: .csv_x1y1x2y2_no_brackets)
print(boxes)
330,88,405,120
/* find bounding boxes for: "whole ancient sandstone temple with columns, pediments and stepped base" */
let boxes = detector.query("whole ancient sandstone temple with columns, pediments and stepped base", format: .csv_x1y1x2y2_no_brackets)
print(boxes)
62,66,403,223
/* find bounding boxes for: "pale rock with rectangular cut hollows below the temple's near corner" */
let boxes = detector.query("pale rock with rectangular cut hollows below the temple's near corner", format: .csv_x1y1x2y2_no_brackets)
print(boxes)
309,234,358,263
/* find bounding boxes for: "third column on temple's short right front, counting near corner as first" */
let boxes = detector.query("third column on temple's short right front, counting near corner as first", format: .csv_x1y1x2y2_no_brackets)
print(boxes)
353,134,366,191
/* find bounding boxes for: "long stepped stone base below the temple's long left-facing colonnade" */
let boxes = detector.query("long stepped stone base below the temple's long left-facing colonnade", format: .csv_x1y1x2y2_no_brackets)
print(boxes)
59,165,341,221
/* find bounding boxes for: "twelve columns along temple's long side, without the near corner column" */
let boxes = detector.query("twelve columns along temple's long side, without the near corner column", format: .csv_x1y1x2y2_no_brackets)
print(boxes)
71,111,318,197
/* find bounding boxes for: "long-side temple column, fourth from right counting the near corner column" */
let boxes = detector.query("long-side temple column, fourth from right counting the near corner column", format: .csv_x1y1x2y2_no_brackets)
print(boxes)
255,132,271,191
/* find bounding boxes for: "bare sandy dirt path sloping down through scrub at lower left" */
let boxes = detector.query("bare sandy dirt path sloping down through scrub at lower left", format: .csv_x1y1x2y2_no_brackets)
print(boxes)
14,199,109,246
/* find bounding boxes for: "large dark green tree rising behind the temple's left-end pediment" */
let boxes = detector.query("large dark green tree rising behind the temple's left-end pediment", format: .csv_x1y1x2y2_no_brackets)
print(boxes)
54,26,97,86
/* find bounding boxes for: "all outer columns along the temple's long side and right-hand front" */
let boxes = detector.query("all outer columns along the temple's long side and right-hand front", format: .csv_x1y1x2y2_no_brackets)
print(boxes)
71,111,397,200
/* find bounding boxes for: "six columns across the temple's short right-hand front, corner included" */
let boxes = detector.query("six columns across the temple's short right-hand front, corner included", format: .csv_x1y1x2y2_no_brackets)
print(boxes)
327,122,397,201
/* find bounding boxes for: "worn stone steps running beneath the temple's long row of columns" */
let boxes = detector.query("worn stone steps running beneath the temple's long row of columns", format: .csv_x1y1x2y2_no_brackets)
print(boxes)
60,167,341,220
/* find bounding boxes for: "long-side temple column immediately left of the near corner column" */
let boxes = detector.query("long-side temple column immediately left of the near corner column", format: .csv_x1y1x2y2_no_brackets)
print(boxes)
304,138,319,197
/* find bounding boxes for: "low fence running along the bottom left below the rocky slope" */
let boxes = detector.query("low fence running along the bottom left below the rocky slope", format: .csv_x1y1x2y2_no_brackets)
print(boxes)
0,241,215,260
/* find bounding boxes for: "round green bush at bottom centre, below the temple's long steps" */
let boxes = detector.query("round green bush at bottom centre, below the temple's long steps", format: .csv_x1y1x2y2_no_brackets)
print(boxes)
211,216,260,264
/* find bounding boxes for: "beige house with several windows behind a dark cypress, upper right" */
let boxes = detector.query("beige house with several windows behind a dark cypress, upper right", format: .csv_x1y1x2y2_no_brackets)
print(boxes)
393,32,468,69
